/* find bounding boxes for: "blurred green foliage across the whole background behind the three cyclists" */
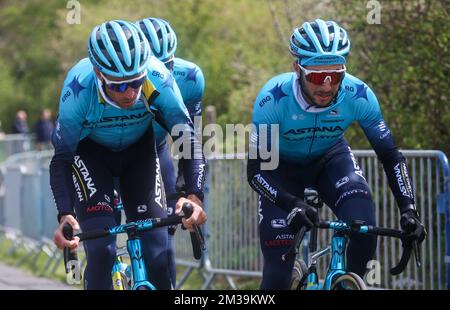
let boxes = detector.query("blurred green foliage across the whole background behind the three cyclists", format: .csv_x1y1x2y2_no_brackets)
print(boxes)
0,0,450,153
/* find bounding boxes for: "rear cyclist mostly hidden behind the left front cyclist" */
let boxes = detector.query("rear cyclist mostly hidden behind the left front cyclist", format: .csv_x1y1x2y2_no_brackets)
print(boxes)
136,17,205,284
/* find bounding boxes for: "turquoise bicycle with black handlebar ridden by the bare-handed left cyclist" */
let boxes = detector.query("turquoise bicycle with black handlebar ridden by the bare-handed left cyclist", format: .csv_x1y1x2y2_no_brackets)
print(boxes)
63,203,205,290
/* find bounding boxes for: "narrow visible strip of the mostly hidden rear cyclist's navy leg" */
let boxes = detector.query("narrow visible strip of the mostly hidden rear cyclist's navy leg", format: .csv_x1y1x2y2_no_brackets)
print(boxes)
157,139,177,287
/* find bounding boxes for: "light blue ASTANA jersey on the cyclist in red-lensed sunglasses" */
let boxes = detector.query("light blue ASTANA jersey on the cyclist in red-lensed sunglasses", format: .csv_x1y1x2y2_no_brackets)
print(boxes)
253,73,392,164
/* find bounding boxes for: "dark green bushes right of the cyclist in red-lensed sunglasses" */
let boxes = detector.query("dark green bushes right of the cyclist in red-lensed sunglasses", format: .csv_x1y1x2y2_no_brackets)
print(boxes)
334,0,450,154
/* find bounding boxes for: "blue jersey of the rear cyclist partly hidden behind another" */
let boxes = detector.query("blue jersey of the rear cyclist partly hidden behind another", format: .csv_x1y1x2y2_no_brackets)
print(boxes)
154,58,205,145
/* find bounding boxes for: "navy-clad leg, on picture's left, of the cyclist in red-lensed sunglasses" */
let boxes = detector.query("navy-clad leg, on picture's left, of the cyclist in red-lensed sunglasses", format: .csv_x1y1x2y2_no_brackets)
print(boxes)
259,163,304,290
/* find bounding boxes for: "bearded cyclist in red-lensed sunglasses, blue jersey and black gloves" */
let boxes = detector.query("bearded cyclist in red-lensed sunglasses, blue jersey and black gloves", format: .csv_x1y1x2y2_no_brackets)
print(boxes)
247,19,426,289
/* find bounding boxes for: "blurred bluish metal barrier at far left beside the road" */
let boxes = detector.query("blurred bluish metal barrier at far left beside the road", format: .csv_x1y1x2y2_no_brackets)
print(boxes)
0,151,61,275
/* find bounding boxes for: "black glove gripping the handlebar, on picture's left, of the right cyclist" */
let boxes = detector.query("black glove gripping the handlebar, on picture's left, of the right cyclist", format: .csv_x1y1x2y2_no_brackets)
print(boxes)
286,200,319,232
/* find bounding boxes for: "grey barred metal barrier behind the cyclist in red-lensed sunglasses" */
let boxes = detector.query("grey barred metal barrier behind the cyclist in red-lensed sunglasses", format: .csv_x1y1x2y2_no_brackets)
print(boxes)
176,150,450,289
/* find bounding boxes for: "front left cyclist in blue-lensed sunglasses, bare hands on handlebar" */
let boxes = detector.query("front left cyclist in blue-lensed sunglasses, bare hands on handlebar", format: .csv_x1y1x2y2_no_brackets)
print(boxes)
50,20,206,289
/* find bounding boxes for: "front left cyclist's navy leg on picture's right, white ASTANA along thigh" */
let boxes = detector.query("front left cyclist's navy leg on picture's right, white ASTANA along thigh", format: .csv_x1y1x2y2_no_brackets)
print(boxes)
120,133,171,289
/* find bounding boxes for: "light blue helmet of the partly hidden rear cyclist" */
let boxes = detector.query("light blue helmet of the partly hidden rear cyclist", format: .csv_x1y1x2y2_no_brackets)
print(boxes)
136,17,177,62
